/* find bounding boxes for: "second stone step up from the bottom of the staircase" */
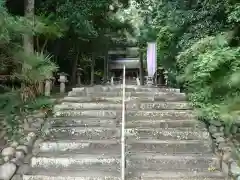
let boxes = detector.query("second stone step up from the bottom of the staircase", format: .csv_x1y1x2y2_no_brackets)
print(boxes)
31,152,217,173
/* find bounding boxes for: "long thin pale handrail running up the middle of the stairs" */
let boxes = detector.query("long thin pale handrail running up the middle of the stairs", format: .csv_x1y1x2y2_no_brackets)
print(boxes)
121,65,126,180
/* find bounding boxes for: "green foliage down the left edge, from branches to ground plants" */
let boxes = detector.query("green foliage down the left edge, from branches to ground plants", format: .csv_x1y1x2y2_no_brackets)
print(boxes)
0,0,58,138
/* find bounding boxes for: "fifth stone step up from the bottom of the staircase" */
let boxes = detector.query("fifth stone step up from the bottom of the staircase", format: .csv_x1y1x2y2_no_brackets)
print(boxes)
49,116,202,129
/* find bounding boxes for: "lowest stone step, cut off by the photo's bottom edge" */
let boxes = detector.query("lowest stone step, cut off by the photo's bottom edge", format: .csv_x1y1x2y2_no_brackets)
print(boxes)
23,168,224,180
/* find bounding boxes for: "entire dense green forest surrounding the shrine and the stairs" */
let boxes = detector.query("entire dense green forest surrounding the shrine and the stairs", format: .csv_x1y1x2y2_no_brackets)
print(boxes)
0,0,240,139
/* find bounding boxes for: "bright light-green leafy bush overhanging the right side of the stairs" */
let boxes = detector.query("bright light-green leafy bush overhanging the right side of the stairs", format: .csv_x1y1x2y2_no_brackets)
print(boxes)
177,33,240,130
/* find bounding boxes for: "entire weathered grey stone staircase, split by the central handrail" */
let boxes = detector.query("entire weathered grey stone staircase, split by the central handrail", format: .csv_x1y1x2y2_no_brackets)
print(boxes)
23,86,225,180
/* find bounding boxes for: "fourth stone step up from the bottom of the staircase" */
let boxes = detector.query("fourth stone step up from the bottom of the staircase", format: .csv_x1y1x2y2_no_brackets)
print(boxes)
49,127,209,140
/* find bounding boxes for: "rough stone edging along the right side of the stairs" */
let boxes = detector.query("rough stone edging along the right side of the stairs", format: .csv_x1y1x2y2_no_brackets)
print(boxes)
208,120,240,180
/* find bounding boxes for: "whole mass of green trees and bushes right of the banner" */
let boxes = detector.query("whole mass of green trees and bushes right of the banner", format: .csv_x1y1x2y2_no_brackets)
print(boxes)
133,0,240,132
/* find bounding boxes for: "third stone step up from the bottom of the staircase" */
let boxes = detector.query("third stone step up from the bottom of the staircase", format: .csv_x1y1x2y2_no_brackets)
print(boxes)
38,140,212,154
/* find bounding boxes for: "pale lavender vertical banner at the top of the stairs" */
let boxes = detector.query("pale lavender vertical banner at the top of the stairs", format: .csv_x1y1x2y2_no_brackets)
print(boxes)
147,42,157,77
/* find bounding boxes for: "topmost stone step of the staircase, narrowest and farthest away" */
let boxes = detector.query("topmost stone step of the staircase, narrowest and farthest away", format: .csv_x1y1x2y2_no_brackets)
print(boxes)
72,85,180,93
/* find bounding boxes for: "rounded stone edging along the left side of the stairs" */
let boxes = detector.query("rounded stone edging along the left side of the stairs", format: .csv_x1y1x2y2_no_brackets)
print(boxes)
0,112,47,180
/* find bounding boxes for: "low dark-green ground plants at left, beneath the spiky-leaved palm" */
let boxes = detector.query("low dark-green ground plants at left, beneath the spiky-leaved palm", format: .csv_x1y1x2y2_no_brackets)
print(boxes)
0,90,53,139
